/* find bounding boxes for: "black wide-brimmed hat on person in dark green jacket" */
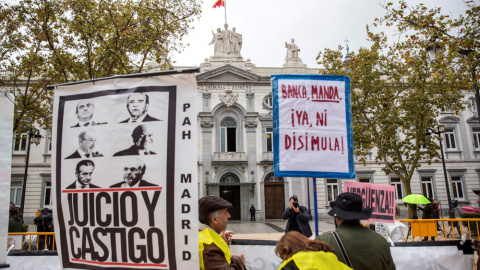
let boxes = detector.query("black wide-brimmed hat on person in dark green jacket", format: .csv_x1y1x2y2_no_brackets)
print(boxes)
328,193,372,220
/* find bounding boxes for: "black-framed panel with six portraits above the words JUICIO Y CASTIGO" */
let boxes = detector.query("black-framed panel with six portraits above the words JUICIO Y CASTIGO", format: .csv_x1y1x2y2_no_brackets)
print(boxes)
56,86,176,269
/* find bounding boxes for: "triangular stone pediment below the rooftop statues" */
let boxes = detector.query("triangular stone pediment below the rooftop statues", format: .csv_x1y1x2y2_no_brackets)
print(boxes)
197,64,269,83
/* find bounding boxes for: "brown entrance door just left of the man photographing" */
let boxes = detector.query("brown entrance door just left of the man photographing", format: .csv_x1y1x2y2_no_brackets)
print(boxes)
265,182,285,219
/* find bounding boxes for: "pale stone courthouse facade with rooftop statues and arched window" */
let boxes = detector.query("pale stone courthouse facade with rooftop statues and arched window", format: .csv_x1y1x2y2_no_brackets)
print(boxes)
6,23,480,222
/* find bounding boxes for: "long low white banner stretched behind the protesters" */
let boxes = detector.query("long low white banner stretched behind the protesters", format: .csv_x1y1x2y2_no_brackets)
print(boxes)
7,239,474,270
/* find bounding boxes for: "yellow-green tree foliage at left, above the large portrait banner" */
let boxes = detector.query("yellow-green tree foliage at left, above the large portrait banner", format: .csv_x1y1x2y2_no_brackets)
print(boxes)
0,0,201,132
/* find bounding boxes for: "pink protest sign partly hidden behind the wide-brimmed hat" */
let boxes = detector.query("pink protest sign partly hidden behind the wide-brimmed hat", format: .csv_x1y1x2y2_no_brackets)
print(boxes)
343,181,395,223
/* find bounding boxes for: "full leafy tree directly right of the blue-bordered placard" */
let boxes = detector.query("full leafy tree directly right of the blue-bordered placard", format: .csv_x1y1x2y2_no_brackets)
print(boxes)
317,23,462,211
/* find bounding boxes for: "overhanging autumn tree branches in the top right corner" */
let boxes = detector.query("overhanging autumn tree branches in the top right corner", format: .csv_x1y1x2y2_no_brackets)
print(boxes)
377,0,480,120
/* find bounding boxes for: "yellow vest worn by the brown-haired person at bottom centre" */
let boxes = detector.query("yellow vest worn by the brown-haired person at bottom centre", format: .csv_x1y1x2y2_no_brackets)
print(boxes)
278,251,352,270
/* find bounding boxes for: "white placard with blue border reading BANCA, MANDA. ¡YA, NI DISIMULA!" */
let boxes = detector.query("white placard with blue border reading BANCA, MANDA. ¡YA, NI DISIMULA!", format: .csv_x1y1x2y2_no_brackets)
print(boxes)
272,75,355,179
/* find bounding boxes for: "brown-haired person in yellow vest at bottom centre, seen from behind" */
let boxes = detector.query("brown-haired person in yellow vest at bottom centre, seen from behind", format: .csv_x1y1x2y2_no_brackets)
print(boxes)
275,231,351,270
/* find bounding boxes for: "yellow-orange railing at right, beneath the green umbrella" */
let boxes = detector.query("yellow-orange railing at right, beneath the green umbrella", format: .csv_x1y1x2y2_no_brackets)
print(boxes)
398,218,480,242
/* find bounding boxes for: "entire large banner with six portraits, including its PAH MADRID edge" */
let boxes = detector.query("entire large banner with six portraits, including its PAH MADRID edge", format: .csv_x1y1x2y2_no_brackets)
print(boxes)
52,74,198,269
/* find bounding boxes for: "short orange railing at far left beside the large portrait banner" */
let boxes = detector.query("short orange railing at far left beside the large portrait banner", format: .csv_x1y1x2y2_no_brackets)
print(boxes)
7,232,55,251
